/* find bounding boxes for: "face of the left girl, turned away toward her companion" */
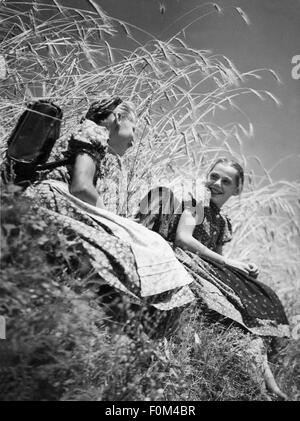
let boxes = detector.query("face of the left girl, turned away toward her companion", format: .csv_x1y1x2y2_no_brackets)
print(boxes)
108,114,135,156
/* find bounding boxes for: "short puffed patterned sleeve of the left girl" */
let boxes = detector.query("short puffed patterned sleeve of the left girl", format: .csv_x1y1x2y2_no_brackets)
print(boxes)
64,119,108,184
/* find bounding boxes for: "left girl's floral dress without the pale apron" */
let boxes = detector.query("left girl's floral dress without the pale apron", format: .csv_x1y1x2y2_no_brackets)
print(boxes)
25,120,139,302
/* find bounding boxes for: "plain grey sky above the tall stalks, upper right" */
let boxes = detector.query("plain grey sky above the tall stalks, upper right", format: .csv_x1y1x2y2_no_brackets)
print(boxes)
9,0,300,180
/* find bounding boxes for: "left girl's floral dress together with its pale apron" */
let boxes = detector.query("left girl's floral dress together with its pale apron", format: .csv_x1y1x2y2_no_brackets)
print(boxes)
26,122,195,311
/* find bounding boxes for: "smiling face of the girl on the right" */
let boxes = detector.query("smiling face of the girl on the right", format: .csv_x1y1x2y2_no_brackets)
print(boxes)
205,163,238,208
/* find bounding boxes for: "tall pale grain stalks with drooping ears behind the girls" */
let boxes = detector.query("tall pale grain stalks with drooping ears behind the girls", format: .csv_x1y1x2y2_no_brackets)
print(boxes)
0,0,300,396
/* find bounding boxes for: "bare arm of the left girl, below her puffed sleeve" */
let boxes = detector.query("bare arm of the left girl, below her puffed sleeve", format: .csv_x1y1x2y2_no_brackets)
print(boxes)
70,154,104,208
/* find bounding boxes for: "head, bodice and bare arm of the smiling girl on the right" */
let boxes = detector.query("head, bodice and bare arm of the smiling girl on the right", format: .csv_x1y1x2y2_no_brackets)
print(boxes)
175,158,259,277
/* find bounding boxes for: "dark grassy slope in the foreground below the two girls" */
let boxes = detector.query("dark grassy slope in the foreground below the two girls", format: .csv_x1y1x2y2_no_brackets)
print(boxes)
0,185,268,400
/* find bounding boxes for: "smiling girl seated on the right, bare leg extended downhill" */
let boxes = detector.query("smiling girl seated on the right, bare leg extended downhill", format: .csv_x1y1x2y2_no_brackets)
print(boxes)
139,158,289,398
